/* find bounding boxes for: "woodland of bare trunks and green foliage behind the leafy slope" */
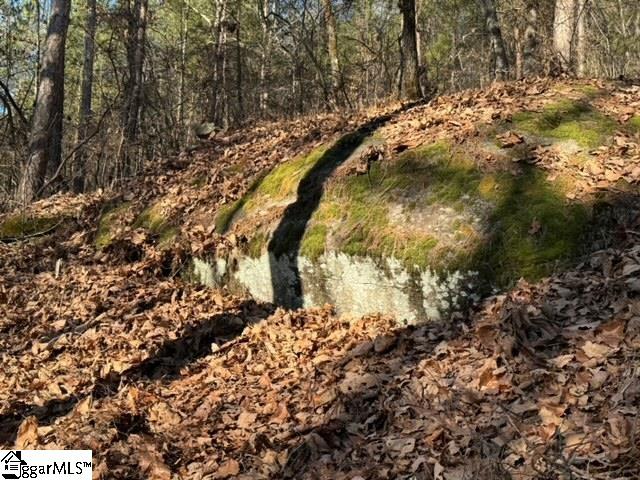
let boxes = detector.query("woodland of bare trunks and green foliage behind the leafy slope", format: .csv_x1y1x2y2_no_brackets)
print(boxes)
0,0,640,204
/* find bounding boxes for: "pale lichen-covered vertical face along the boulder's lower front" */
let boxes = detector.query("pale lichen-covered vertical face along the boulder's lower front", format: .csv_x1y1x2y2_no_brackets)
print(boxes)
194,252,476,324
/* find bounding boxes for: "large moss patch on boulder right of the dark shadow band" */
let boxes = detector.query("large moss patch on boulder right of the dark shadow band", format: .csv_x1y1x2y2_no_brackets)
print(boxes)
304,139,589,286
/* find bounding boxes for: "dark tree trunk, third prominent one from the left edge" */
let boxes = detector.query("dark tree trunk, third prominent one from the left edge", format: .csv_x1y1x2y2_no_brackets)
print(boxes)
122,0,148,175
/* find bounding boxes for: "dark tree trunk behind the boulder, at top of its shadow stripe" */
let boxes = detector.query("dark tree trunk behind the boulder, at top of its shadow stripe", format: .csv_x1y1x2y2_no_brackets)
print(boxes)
398,0,422,100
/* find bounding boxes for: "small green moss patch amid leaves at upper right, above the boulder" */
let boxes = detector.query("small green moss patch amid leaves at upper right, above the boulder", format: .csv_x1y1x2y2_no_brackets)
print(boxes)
513,100,616,148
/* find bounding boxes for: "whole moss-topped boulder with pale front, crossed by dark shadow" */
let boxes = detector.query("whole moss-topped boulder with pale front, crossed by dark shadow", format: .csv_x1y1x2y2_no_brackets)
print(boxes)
194,89,632,321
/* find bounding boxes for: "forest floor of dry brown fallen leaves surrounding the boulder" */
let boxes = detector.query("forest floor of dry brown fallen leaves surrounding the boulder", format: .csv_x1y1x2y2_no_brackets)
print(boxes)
0,77,640,480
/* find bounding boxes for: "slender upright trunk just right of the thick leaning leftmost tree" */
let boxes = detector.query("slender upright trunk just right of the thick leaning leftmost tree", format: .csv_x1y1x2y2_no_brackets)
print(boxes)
73,0,97,192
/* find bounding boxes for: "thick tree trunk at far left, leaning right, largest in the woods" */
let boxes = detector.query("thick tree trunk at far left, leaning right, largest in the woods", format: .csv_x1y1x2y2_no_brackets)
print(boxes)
18,0,71,203
